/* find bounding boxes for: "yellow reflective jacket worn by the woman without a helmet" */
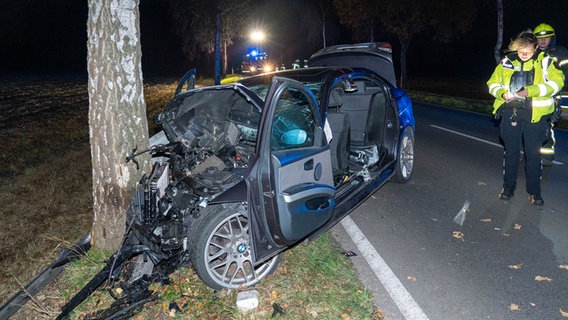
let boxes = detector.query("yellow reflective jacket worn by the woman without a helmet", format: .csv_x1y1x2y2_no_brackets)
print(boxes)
487,52,564,122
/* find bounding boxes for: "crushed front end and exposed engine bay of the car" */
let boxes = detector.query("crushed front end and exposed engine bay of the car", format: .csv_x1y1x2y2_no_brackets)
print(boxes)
53,85,259,319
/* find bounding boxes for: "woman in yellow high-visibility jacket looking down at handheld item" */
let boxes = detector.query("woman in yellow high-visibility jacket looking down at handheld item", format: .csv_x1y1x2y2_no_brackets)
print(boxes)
487,30,564,205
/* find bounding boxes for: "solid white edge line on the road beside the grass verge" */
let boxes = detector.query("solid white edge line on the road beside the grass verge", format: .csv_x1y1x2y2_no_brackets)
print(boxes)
341,216,428,320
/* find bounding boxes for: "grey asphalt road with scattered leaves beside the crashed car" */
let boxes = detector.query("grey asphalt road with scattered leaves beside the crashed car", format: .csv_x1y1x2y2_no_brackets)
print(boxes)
333,104,568,320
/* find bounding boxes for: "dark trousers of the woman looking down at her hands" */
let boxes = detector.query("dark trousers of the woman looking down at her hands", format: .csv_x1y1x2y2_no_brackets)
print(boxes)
501,109,550,194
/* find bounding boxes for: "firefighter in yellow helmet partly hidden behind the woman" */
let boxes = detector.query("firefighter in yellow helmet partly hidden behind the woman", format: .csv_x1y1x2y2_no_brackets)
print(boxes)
533,23,568,165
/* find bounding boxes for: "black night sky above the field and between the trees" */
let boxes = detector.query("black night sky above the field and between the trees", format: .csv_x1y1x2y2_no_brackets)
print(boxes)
0,0,568,78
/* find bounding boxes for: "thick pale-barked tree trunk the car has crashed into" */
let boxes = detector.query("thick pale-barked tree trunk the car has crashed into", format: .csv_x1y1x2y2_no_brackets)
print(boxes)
87,0,150,250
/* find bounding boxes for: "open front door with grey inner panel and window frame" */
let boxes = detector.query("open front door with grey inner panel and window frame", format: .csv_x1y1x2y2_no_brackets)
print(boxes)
251,77,335,261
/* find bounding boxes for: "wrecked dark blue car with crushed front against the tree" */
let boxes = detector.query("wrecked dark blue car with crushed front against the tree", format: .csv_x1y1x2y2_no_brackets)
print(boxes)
55,43,415,313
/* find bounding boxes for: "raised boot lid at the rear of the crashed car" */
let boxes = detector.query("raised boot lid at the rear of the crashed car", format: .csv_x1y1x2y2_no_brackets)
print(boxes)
308,42,396,87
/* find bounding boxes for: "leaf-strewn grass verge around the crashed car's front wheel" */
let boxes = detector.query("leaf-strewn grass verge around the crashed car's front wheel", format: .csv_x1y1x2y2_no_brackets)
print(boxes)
60,233,383,320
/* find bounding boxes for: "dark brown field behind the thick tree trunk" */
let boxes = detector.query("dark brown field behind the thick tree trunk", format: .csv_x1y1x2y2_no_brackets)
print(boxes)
0,76,175,304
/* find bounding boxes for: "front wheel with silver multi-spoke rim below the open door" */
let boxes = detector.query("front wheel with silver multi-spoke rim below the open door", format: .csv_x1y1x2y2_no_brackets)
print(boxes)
189,204,279,290
